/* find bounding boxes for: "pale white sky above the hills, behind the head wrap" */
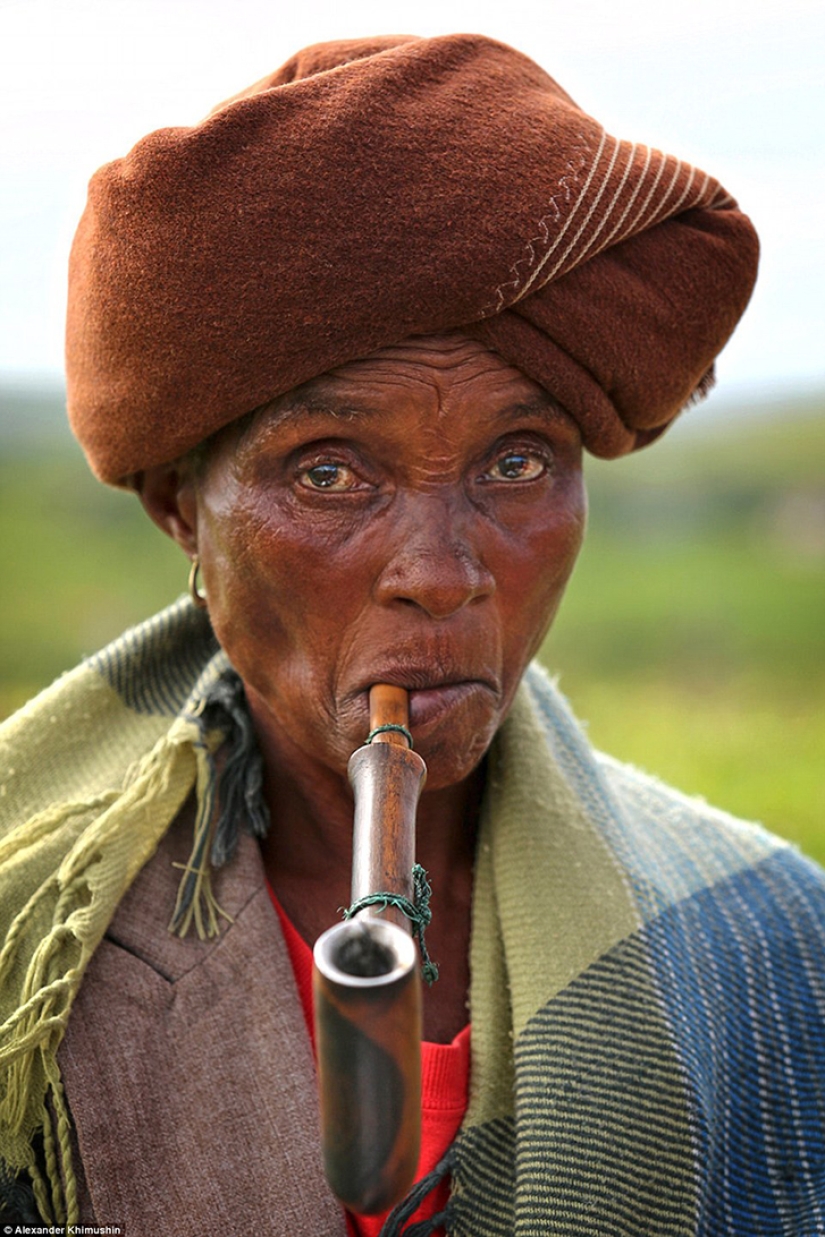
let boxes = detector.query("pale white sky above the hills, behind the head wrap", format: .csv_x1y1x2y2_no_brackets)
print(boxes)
0,0,825,392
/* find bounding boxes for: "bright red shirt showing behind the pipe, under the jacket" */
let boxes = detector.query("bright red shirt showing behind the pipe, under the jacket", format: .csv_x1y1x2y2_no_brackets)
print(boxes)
270,887,470,1237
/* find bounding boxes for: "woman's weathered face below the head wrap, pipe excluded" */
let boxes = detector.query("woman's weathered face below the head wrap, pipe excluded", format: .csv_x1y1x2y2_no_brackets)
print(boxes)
181,335,585,789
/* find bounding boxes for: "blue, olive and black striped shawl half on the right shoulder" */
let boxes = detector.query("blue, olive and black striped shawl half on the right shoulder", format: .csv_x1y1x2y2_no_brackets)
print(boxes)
453,670,825,1237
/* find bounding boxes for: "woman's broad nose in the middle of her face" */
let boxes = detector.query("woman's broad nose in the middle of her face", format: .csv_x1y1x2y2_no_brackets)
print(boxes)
377,496,496,619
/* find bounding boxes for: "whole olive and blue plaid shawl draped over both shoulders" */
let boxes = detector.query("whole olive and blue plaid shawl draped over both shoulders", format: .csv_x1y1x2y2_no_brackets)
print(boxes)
0,601,825,1237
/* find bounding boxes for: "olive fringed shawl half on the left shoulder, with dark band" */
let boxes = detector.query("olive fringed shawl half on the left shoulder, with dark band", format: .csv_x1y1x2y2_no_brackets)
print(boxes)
0,600,248,1225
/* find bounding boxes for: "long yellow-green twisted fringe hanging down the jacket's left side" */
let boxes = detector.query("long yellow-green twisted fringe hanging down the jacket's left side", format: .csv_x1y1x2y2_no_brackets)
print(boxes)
0,719,205,1225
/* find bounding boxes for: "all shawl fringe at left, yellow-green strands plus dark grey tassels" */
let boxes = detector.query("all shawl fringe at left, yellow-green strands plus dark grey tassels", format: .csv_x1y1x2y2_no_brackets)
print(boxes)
0,651,268,1227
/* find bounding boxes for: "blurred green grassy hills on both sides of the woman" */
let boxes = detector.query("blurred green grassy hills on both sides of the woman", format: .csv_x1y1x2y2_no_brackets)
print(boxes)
0,385,825,862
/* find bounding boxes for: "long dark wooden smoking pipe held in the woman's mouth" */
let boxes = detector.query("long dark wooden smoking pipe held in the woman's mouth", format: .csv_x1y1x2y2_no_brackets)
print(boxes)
313,684,427,1215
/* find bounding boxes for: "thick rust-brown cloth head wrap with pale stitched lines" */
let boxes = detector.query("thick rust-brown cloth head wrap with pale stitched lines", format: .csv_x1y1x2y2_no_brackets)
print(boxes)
67,35,757,482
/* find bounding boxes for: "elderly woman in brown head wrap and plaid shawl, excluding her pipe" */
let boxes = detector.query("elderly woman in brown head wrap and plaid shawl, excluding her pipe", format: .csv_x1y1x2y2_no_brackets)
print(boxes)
0,29,825,1237
